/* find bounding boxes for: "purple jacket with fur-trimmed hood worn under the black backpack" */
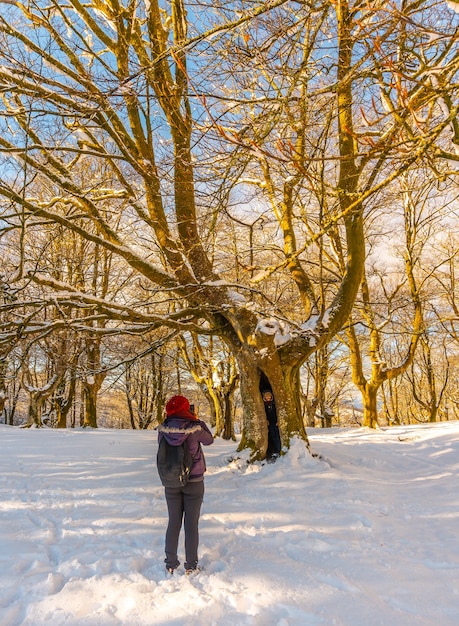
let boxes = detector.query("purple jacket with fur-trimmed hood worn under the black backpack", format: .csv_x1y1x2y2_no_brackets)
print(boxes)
158,414,214,482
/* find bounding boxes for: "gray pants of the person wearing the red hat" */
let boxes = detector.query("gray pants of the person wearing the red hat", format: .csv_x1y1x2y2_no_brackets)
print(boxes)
164,480,204,569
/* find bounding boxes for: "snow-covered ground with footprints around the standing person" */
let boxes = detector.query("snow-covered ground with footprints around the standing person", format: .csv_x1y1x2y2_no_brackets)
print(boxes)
0,422,459,626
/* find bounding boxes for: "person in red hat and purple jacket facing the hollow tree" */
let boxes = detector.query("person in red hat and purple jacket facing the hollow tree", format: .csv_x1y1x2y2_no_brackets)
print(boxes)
158,395,214,574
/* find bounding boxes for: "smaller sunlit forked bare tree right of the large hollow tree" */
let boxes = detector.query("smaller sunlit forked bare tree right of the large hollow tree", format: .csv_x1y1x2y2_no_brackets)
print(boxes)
346,171,441,428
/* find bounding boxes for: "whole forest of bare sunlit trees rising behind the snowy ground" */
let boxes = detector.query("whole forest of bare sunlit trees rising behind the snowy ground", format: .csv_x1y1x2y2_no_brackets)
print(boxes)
0,0,459,459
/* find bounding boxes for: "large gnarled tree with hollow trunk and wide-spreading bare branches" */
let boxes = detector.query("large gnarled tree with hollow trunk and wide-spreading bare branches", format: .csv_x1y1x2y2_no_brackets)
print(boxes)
0,0,458,458
